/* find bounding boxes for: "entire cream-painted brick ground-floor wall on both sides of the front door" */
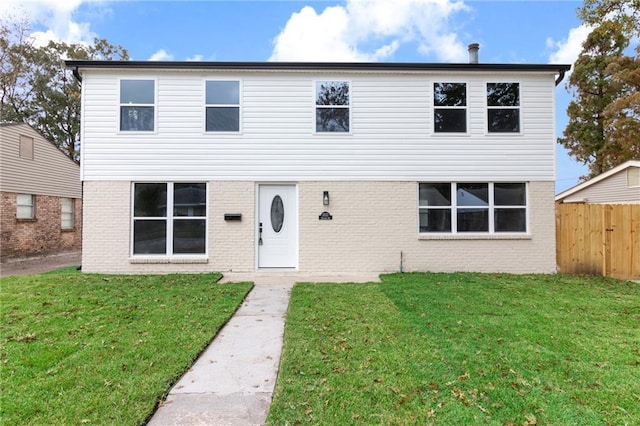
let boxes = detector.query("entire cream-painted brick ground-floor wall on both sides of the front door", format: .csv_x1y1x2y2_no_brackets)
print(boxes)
82,181,556,273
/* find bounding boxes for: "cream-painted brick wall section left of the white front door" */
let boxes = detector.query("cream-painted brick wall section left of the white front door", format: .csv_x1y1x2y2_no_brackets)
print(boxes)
82,181,255,273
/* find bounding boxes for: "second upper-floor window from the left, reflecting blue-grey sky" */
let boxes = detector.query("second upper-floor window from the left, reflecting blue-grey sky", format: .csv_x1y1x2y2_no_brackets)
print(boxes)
205,80,240,132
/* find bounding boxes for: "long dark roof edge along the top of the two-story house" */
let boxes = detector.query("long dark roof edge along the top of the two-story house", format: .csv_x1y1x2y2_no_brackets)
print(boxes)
65,60,571,73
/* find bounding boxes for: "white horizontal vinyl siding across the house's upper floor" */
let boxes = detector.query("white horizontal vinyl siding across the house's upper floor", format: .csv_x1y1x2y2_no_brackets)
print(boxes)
82,70,556,181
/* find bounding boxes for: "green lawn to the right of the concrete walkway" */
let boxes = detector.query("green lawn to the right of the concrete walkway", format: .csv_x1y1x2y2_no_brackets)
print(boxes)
268,273,640,425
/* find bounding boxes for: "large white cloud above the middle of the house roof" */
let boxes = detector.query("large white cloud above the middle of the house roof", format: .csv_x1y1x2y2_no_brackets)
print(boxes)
270,0,468,62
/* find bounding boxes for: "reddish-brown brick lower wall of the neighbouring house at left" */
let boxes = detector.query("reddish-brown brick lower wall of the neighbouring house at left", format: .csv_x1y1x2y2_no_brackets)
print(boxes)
0,192,82,260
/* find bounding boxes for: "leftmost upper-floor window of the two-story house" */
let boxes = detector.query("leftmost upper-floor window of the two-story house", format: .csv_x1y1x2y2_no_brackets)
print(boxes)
120,80,155,132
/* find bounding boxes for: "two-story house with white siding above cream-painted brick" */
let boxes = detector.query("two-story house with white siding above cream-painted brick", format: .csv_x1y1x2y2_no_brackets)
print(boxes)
67,51,569,273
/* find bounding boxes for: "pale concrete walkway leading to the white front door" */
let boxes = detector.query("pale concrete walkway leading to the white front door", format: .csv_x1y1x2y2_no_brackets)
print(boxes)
148,272,379,426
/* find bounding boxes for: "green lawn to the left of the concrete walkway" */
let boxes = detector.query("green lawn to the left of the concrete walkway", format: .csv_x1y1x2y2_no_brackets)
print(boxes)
0,268,251,425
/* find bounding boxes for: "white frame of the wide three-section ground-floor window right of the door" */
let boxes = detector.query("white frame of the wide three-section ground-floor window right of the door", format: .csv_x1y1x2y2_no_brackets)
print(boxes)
416,181,531,240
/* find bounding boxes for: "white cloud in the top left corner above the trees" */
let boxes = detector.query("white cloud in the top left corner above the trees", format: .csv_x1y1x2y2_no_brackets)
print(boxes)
0,0,99,46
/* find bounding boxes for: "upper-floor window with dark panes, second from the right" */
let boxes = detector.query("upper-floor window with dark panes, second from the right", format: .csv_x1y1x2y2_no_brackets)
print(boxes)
433,83,467,133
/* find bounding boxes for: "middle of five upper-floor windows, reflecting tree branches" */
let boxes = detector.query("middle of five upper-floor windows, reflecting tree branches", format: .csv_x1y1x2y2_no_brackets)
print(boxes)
316,81,349,133
